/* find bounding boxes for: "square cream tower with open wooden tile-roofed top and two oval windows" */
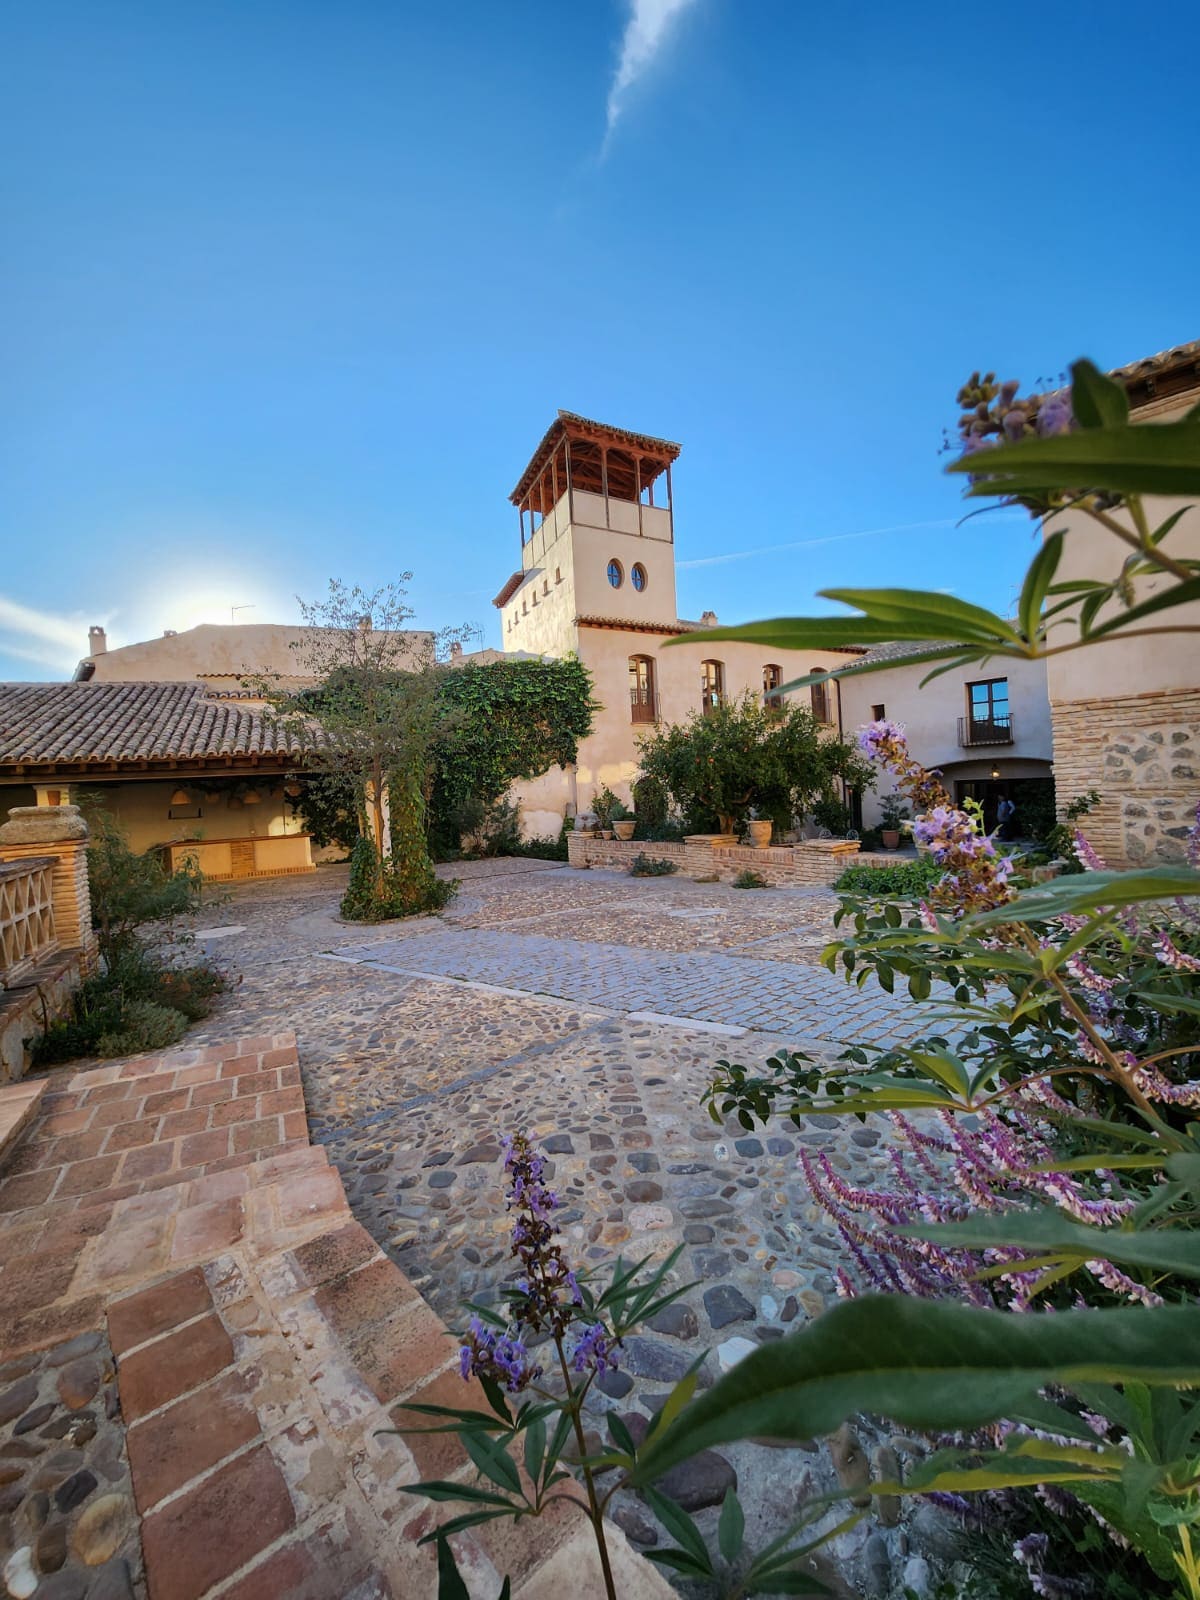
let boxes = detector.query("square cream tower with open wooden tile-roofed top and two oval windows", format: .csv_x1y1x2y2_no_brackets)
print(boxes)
496,411,680,654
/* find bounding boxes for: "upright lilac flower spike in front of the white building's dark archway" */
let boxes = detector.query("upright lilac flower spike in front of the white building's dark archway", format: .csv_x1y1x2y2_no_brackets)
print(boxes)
858,722,1013,931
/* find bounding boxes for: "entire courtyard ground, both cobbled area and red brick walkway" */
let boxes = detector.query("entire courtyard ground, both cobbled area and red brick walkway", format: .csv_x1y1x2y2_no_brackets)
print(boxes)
0,861,960,1600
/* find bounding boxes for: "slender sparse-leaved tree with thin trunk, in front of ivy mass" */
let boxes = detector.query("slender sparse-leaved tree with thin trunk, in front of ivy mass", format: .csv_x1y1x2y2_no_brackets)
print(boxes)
272,573,453,915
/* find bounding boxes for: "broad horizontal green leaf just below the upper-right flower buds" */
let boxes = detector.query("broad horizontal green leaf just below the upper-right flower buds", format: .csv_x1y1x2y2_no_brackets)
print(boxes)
946,418,1200,496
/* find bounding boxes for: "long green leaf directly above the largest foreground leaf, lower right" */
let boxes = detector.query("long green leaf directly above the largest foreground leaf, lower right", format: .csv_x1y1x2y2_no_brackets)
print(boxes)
899,1211,1200,1273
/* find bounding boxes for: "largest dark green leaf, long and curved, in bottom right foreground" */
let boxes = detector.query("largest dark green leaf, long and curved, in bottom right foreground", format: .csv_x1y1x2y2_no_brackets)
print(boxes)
630,1292,1200,1485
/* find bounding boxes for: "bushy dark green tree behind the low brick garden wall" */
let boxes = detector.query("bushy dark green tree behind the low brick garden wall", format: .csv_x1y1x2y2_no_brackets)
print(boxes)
638,693,872,834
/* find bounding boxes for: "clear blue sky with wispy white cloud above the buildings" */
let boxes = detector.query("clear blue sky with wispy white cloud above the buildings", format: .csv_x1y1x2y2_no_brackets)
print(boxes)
0,0,1200,678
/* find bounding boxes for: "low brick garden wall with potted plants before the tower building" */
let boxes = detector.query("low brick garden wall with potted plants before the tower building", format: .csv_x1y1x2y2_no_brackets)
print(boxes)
566,834,859,888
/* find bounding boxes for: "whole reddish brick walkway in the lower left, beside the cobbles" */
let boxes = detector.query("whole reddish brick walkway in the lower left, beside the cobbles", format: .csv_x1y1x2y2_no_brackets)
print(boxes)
0,1034,670,1600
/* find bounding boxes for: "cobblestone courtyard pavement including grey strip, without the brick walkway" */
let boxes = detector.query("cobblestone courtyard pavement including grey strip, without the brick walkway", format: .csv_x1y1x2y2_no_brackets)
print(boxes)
178,861,947,1595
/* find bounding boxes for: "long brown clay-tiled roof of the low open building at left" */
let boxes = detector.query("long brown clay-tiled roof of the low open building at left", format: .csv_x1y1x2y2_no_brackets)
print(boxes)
0,683,307,768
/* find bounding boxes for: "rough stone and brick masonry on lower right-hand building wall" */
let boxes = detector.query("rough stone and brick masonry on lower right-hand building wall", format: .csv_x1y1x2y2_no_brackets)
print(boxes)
1051,690,1200,867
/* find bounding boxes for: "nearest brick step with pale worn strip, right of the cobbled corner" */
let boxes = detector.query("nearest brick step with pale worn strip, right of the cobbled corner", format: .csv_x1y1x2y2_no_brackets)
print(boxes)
109,1209,672,1600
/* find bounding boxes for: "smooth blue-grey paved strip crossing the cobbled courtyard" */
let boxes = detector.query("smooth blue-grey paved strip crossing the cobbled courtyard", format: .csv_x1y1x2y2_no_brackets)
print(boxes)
330,928,933,1045
